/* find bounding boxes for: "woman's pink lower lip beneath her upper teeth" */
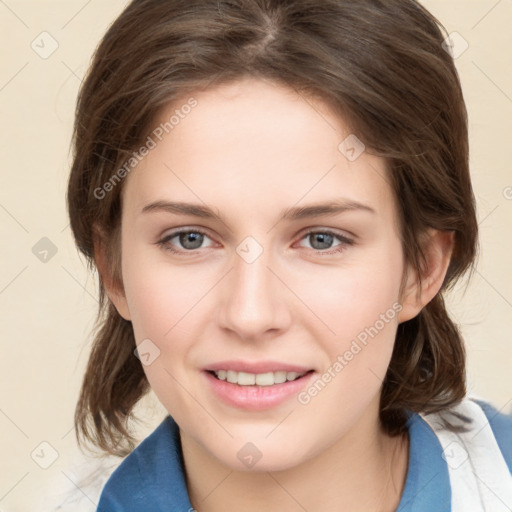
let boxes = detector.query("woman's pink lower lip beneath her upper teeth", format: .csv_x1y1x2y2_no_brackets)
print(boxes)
203,371,315,411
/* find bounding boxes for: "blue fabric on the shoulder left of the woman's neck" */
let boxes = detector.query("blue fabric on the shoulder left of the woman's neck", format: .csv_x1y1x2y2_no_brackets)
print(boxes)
97,416,188,512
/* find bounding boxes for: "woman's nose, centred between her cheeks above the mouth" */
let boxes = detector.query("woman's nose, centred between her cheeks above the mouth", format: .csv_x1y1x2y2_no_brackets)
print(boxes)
218,247,292,341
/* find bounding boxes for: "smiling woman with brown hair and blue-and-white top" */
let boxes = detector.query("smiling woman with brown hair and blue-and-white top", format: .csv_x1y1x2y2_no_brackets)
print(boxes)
68,0,512,512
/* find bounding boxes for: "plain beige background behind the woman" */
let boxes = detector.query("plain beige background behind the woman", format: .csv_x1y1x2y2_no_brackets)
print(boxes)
0,0,512,512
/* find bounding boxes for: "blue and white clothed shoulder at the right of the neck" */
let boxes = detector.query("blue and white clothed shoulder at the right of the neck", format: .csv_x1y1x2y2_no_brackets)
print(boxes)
398,397,512,512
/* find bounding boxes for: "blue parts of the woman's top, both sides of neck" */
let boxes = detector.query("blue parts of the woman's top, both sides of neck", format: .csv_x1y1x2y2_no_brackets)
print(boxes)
97,401,512,512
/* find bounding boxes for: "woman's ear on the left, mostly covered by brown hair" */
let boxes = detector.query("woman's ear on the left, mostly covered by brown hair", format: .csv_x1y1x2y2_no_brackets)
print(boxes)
93,228,131,320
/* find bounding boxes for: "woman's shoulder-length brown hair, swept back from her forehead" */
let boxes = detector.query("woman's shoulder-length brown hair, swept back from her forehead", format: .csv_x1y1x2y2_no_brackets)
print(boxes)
67,0,477,455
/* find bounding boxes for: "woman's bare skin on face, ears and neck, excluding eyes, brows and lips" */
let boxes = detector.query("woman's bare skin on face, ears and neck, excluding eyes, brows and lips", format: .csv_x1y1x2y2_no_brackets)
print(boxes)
96,79,453,512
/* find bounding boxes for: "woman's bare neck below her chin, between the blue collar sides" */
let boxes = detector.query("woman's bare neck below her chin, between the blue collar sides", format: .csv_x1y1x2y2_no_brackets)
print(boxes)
181,404,409,512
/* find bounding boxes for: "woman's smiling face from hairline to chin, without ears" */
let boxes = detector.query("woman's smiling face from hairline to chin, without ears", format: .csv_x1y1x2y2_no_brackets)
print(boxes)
111,80,412,470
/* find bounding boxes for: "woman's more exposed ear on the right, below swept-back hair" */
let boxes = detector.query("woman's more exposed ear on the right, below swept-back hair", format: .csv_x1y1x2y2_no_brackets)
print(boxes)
398,229,454,323
